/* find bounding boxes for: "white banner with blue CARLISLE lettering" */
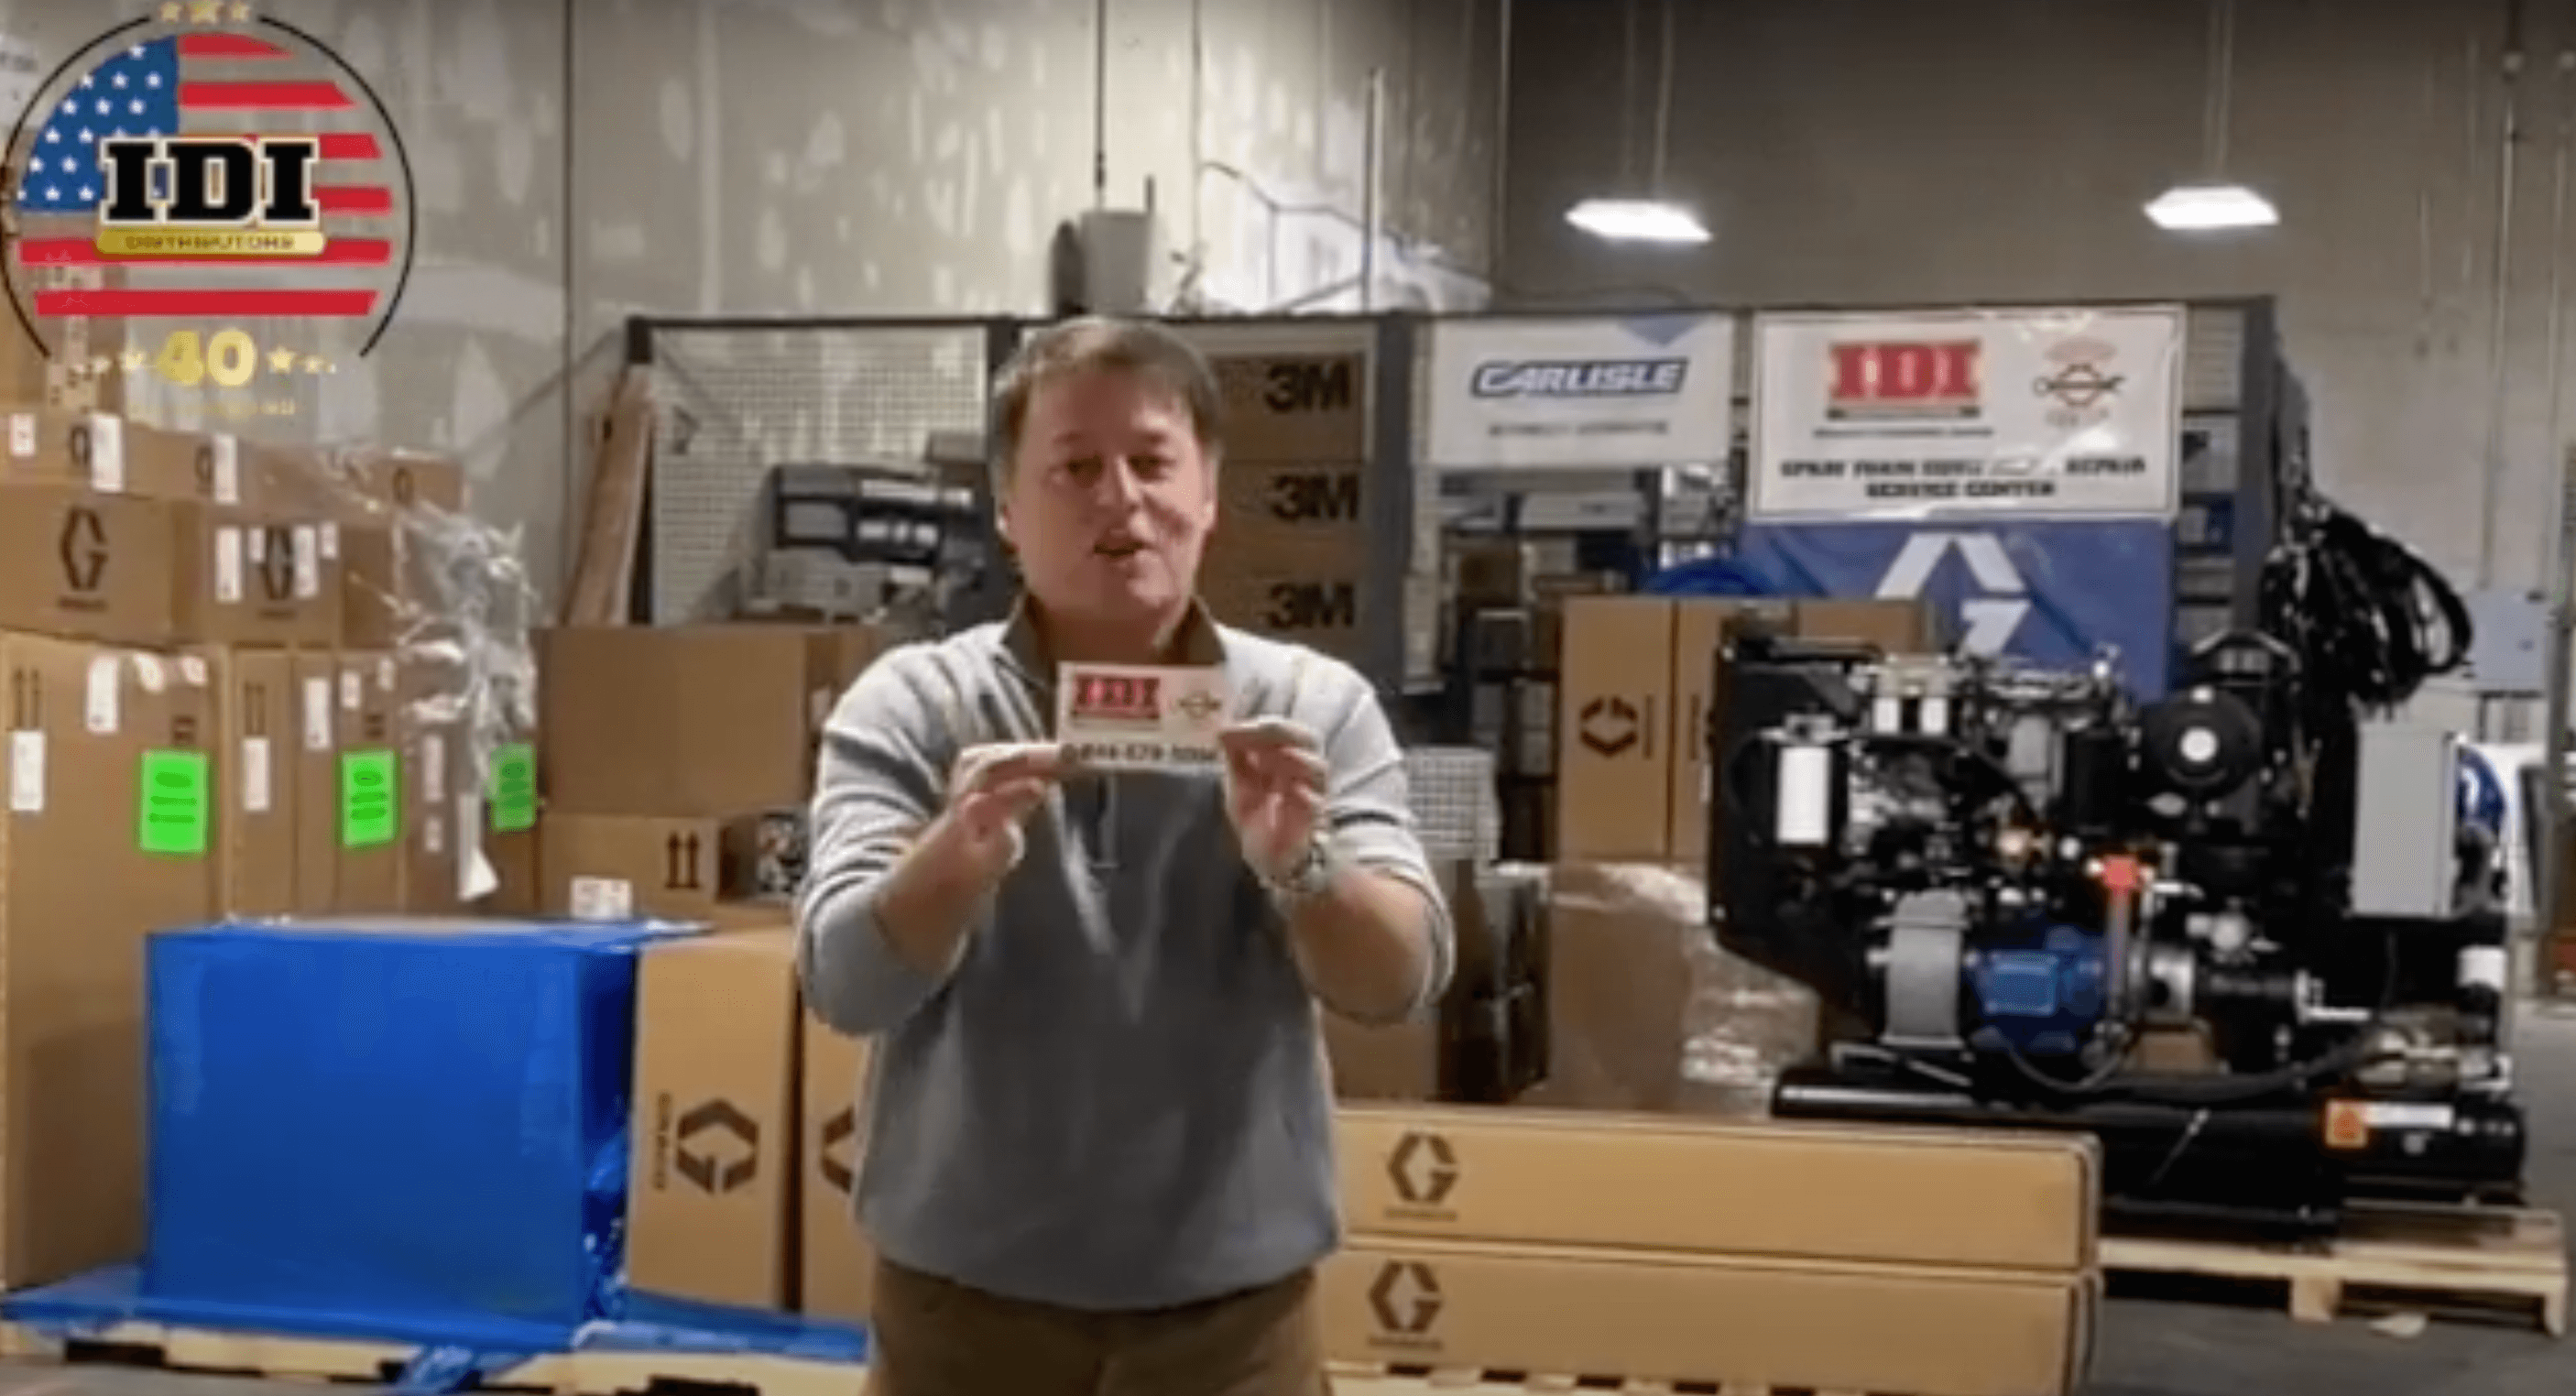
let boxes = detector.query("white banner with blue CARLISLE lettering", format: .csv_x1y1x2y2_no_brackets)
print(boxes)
1422,311,1736,472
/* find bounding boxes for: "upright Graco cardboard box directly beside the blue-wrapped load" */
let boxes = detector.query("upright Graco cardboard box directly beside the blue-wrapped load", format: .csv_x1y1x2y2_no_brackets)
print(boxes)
626,930,802,1308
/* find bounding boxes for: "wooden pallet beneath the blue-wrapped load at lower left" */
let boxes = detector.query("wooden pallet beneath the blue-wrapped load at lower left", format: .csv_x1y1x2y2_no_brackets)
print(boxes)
0,1321,863,1396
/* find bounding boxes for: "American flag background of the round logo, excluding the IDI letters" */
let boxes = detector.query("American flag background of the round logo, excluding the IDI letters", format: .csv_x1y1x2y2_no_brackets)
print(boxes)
7,10,409,343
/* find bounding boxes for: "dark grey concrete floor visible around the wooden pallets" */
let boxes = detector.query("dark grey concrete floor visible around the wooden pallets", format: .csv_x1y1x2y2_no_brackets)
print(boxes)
0,1009,2576,1396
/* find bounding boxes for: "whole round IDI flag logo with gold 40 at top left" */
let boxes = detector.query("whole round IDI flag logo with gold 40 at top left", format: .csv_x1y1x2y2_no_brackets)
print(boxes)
0,0,415,418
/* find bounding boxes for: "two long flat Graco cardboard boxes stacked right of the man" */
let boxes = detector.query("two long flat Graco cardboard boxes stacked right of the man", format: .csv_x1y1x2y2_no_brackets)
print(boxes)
1324,1107,2102,1396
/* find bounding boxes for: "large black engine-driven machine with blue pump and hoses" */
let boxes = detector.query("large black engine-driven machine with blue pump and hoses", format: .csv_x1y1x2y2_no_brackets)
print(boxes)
1710,499,2525,1231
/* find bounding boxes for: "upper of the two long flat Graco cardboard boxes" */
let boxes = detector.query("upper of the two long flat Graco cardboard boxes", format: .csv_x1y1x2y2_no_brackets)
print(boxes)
1337,1105,2102,1272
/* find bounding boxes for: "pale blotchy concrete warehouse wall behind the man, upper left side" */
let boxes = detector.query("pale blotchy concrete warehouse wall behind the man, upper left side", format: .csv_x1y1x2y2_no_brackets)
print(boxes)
0,0,1500,600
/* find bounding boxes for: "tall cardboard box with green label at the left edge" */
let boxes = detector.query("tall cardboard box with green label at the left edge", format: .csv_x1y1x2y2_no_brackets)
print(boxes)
0,634,219,1291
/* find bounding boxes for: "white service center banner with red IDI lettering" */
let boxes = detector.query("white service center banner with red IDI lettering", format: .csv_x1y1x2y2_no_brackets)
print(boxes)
1747,307,2185,520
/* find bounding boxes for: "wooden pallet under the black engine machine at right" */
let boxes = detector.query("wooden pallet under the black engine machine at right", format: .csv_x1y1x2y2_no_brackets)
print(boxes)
2102,1205,2569,1336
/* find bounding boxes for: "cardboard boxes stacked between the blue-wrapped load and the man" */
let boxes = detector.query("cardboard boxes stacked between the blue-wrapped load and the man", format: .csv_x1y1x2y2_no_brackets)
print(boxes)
533,623,884,1321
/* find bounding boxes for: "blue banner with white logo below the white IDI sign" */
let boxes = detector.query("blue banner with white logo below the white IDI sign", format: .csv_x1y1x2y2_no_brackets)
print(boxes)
1733,520,2174,701
